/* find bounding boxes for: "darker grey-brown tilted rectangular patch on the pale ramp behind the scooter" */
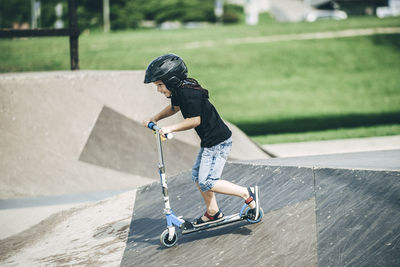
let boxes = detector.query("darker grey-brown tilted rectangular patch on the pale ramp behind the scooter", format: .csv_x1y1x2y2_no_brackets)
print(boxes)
79,107,198,179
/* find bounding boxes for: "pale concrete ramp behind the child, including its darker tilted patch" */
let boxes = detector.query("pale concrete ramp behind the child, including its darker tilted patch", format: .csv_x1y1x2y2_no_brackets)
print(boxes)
0,71,268,199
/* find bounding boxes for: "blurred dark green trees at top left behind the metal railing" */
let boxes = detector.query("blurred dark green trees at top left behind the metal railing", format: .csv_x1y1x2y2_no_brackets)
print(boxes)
0,0,222,30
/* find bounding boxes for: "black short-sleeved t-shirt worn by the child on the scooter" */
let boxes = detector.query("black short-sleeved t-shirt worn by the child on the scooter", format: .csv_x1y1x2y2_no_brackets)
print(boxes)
171,87,232,147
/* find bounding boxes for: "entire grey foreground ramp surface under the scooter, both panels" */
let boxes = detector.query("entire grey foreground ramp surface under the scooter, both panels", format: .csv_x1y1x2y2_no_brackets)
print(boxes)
122,157,400,266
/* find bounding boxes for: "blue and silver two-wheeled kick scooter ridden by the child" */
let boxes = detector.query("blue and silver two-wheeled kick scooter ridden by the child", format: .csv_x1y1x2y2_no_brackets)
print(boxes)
147,122,264,248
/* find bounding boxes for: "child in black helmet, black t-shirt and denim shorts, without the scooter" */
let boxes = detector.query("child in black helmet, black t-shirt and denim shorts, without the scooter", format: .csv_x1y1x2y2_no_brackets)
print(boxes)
143,54,260,245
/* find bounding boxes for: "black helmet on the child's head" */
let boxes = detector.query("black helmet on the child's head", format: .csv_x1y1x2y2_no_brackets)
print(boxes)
144,54,187,89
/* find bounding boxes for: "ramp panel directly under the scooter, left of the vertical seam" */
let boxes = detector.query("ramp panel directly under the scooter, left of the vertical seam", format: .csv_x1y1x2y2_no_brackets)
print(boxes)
122,164,317,266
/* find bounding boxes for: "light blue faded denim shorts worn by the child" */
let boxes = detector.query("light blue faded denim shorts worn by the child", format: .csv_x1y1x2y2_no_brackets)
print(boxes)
192,137,232,192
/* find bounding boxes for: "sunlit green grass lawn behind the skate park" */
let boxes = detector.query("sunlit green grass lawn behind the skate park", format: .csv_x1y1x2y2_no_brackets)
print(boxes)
0,16,400,143
